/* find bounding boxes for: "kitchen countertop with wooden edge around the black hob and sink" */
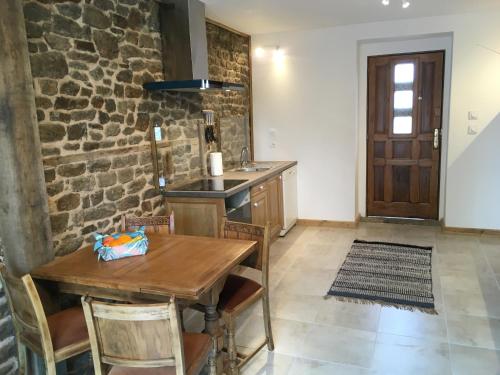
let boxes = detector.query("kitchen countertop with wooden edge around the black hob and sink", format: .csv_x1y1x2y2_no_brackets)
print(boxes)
163,161,297,198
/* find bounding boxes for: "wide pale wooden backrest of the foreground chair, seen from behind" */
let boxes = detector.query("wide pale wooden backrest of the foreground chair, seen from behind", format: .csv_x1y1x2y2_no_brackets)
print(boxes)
82,297,186,375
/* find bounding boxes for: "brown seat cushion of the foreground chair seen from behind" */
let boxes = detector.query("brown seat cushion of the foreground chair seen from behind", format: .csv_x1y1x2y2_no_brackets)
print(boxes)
108,332,211,375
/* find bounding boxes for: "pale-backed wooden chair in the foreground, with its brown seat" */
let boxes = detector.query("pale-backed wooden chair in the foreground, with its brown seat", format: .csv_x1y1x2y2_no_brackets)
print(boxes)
82,297,212,375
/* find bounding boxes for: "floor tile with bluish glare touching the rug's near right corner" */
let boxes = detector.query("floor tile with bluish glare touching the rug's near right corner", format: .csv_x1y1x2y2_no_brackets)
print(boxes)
378,307,448,342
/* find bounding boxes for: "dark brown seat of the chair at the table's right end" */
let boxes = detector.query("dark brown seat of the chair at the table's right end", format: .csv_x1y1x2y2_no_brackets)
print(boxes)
218,275,264,313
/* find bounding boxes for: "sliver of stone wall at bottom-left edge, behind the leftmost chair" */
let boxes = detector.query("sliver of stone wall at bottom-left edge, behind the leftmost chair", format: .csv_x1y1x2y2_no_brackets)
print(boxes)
0,238,18,375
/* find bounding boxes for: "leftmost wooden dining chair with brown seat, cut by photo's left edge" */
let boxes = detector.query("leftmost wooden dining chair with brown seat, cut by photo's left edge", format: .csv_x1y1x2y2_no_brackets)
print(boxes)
0,263,90,375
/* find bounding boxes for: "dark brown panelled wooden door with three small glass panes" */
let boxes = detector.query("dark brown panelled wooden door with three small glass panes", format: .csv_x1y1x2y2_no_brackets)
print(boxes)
367,51,444,219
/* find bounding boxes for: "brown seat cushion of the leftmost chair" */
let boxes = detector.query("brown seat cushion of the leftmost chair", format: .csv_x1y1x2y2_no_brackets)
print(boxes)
47,306,89,351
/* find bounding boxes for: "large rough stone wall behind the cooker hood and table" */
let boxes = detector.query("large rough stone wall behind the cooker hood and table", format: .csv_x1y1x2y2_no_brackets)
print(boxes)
24,0,250,255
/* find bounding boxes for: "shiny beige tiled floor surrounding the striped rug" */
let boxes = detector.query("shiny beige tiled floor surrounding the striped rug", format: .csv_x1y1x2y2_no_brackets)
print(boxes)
189,223,500,375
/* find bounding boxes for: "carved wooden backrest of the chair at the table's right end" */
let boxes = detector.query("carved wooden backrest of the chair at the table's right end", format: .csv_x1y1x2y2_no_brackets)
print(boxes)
221,220,270,288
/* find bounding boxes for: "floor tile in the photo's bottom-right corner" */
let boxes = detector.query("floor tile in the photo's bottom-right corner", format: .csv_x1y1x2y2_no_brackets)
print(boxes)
450,345,500,375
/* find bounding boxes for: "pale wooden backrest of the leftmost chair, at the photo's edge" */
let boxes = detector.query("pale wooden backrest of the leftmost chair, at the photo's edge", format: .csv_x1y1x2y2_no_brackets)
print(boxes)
0,263,56,375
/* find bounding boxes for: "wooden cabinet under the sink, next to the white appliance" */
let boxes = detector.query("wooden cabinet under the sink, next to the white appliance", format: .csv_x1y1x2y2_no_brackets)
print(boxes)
251,175,283,238
